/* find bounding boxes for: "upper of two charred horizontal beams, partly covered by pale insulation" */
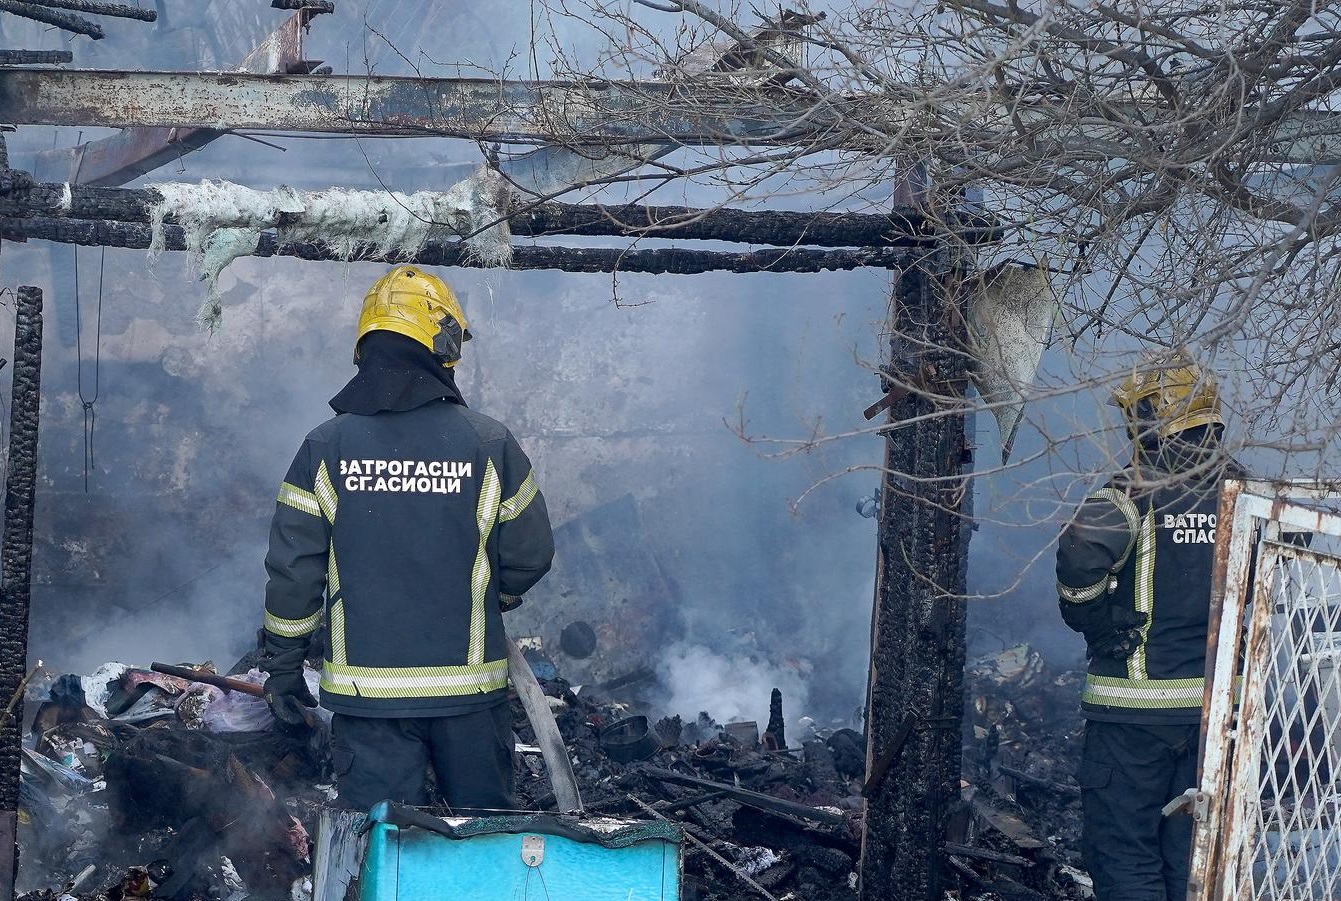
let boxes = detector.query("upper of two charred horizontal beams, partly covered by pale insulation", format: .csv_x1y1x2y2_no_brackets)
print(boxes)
0,182,999,247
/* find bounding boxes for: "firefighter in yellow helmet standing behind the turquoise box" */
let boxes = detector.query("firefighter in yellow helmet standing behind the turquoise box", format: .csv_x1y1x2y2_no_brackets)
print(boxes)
263,265,554,811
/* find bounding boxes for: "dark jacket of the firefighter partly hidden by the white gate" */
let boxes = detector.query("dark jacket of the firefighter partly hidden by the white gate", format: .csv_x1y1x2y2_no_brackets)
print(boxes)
1057,445,1243,724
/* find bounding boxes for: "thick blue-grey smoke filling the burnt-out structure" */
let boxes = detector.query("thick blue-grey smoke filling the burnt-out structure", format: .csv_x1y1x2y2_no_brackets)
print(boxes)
4,1,1287,740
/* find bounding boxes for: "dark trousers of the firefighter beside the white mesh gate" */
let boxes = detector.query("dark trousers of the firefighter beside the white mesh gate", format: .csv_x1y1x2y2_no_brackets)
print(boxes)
1075,720,1200,901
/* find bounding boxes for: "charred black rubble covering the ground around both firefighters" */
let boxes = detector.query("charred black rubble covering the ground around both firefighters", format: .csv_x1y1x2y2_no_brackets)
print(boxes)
20,640,1089,901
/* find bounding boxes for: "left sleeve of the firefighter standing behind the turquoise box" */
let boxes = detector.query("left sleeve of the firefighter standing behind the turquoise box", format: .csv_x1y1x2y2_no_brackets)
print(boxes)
264,440,334,660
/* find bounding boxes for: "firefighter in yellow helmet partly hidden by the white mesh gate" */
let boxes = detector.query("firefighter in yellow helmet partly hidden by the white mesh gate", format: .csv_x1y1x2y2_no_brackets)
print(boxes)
1057,353,1244,901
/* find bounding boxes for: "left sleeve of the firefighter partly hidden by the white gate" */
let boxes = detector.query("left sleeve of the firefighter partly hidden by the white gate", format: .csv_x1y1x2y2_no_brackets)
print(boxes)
1057,488,1140,638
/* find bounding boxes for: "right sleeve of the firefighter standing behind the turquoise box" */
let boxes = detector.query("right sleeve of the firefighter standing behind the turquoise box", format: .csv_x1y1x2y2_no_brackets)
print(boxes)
498,432,554,610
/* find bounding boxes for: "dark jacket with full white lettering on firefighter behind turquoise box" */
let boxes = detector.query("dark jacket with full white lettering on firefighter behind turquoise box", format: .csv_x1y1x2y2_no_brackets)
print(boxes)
264,390,554,717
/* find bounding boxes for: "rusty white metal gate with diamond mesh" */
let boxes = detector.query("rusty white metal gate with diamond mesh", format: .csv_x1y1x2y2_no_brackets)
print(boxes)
1188,481,1341,901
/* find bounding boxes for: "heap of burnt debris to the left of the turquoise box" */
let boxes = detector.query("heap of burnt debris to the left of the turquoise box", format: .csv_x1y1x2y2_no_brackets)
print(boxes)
19,664,329,901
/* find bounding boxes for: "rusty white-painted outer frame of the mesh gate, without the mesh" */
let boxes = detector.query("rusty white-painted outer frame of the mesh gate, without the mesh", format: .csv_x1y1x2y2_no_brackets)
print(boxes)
1187,480,1341,901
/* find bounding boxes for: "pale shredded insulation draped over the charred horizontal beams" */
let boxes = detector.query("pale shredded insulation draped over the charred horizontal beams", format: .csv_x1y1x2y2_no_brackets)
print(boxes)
149,166,512,330
